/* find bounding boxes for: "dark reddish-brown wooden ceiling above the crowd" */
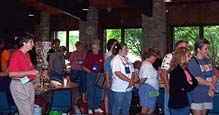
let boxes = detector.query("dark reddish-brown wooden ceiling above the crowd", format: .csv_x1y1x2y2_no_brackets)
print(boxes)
1,0,219,30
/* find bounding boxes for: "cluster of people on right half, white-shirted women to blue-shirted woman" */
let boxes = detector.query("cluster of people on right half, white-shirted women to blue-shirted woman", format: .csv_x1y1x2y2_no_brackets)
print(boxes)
104,39,217,115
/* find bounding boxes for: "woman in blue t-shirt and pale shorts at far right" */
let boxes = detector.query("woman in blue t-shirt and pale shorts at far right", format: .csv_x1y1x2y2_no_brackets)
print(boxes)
188,39,216,115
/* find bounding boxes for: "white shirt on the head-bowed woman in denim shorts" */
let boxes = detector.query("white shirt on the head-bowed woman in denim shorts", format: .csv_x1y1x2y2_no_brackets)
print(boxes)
139,61,159,90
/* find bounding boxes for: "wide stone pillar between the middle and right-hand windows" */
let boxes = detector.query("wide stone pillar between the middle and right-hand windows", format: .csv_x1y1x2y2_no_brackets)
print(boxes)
142,0,167,55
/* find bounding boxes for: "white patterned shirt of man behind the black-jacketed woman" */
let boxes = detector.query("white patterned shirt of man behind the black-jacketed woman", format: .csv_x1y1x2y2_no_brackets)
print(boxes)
161,53,173,71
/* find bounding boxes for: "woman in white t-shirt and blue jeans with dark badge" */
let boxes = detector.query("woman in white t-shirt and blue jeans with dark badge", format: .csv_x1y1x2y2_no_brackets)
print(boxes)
111,44,135,115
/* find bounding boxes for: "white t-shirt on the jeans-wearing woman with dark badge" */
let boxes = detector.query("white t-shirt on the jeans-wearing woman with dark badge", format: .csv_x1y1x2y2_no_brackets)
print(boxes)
111,55,134,92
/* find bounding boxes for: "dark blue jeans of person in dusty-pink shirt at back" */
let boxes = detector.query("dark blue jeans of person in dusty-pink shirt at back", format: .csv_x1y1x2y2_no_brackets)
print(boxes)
70,70,87,93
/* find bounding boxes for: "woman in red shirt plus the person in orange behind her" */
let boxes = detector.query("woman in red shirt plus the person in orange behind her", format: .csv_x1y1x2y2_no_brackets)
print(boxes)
0,34,38,115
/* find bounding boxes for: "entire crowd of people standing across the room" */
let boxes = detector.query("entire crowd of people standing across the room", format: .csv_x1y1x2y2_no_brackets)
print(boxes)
0,32,217,115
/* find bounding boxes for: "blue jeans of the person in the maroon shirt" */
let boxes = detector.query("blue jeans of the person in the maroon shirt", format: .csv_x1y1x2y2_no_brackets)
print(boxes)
87,73,103,109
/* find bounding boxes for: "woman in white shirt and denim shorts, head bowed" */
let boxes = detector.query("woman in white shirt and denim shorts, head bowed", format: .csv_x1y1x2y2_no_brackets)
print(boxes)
139,48,160,115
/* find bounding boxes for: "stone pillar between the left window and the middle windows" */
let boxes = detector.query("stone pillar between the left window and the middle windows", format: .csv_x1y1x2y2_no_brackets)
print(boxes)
79,8,98,48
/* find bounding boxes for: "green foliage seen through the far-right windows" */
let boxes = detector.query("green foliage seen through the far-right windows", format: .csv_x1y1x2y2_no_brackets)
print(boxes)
174,26,219,65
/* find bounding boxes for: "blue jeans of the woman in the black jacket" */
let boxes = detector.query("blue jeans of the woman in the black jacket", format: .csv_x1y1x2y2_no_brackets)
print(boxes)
170,107,189,115
